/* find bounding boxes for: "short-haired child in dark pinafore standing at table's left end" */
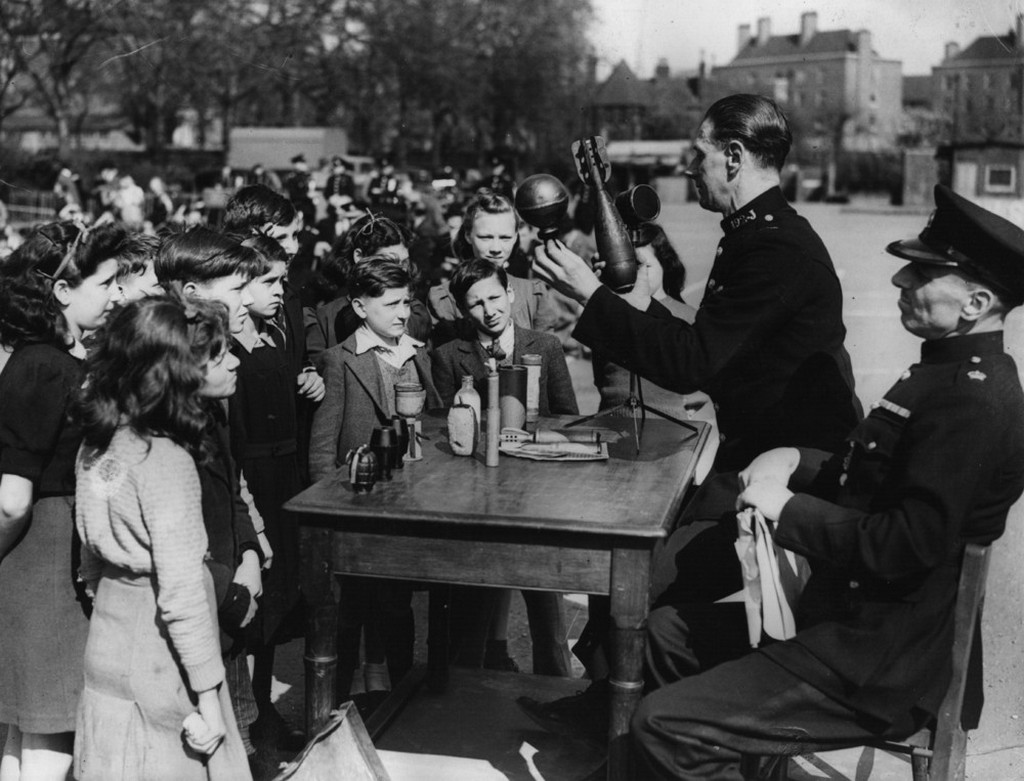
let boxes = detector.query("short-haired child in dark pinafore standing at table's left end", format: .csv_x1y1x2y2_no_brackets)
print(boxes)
228,234,303,745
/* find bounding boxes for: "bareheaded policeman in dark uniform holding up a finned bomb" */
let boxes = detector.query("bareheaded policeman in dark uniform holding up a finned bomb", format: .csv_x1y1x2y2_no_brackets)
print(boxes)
520,94,861,736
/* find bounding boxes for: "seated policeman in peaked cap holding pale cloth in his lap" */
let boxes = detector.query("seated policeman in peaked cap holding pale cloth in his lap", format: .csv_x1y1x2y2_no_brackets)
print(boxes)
633,186,1024,779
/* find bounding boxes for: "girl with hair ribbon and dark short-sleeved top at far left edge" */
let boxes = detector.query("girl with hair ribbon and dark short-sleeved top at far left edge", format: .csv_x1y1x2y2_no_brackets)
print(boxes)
0,222,118,781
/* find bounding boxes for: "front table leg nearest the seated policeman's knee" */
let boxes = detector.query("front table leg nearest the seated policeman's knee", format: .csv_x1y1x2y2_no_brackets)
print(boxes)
608,549,650,781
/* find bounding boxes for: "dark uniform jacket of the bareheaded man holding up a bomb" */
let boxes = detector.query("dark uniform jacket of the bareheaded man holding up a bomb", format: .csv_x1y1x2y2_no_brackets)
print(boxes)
572,187,860,469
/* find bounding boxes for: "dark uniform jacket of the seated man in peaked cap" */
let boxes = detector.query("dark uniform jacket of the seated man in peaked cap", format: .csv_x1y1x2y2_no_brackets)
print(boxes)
764,332,1024,723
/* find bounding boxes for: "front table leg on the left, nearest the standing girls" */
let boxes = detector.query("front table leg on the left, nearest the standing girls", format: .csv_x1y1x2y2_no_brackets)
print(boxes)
299,526,338,739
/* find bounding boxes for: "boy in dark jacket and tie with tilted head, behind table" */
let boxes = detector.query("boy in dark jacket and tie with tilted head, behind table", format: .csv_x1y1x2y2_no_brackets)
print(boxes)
432,258,580,676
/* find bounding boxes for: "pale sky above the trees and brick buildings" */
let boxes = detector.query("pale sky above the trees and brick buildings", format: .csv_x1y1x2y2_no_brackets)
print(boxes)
590,0,1024,78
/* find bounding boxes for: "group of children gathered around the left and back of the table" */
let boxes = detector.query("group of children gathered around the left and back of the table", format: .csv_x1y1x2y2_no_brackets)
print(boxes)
0,174,692,781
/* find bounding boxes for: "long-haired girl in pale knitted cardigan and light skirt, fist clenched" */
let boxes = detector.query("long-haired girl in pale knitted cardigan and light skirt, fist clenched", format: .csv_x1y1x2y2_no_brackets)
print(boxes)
75,298,251,781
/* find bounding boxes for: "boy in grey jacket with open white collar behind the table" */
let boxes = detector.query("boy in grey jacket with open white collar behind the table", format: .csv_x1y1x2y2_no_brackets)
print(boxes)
309,258,440,708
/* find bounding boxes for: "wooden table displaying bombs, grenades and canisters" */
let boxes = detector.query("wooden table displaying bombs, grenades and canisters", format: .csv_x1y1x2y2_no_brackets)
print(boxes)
286,417,710,779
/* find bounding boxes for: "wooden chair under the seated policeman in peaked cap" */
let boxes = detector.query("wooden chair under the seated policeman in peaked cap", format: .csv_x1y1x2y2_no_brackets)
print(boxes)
743,543,989,781
